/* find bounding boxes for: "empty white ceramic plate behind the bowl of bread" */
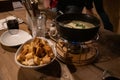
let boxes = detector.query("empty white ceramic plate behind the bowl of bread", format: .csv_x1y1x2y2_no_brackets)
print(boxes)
0,29,32,46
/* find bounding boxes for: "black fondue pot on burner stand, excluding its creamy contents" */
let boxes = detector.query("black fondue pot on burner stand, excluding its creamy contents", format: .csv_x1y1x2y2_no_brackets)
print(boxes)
55,13,100,42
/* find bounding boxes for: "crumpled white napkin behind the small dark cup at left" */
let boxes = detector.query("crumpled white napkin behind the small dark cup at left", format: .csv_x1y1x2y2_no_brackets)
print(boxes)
0,16,23,30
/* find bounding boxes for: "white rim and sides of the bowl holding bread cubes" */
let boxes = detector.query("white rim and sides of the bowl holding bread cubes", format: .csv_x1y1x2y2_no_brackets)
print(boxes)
15,37,57,69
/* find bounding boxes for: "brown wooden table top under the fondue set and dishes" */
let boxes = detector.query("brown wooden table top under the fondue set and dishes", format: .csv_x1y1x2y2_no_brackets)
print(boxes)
0,9,120,80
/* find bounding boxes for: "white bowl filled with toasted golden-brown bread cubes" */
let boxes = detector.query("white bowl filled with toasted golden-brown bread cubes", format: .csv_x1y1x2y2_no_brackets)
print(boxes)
15,37,56,68
